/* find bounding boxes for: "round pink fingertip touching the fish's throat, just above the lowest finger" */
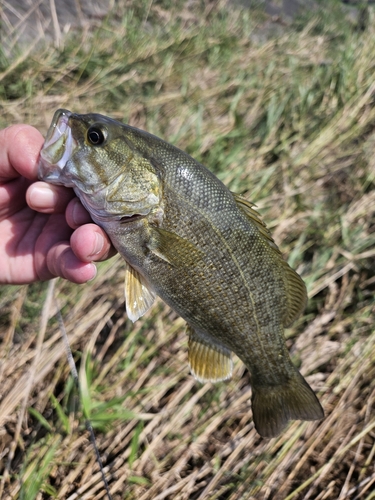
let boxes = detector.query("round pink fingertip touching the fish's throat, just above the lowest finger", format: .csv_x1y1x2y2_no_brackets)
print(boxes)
70,224,116,262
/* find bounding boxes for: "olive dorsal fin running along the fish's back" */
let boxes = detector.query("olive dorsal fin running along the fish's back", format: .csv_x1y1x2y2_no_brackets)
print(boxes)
232,193,307,327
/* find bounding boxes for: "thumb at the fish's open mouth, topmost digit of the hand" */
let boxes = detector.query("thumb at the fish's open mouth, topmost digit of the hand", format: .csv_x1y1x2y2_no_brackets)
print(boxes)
0,125,44,182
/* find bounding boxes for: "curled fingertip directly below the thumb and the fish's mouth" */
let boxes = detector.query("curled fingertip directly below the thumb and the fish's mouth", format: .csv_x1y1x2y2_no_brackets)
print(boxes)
26,181,75,214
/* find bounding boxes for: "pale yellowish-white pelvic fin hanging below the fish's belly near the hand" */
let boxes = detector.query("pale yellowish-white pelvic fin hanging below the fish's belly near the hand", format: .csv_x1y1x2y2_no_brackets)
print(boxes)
125,262,156,323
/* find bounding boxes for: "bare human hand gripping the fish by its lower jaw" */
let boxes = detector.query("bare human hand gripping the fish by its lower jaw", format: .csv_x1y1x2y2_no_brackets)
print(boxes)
0,125,113,284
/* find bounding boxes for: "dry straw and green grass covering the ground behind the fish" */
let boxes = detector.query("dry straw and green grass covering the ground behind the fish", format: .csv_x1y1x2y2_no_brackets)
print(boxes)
0,0,375,500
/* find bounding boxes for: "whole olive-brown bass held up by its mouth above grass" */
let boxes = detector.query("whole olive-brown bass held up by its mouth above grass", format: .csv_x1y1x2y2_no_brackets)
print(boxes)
38,109,324,438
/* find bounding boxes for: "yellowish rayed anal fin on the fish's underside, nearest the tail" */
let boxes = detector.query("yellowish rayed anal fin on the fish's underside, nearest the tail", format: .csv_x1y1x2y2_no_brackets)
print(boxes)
187,325,233,382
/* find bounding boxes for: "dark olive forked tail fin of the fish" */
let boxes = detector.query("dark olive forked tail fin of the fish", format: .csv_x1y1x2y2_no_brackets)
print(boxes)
252,371,324,437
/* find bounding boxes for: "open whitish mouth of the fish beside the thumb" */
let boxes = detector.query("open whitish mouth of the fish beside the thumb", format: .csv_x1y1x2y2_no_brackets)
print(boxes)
38,109,77,185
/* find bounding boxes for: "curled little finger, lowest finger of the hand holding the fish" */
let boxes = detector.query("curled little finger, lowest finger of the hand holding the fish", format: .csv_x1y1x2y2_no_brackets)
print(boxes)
47,242,96,284
